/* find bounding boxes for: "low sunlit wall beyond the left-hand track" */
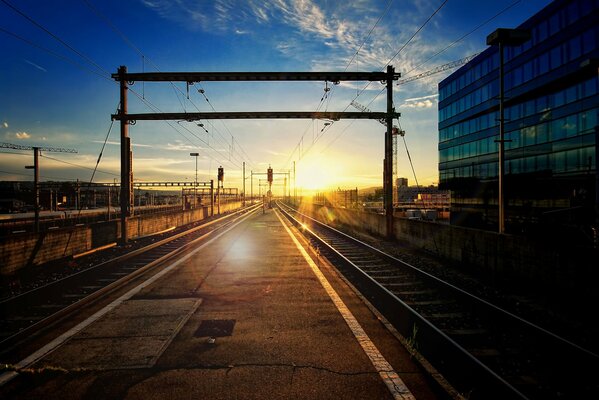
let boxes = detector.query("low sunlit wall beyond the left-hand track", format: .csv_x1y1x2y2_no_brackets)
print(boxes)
0,202,241,276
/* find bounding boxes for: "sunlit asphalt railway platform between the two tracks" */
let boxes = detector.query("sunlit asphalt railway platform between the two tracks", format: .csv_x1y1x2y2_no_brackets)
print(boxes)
0,209,446,400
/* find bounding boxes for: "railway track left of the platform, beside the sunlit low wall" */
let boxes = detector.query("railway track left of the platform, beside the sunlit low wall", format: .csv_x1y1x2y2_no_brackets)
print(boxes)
0,205,260,354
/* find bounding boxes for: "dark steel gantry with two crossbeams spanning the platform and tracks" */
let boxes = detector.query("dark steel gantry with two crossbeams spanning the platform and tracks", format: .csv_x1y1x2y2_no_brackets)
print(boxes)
112,65,400,243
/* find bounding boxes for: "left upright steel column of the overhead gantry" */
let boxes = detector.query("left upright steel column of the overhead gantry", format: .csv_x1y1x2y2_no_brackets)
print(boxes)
119,66,132,245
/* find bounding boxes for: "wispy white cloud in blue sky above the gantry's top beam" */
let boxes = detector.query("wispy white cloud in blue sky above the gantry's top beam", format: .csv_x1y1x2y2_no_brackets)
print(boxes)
140,0,448,72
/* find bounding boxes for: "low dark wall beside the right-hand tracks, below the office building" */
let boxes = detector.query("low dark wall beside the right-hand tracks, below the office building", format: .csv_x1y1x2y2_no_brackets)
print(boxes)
301,204,599,291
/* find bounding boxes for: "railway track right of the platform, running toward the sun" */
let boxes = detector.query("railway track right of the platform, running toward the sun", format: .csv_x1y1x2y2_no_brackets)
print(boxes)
279,204,599,399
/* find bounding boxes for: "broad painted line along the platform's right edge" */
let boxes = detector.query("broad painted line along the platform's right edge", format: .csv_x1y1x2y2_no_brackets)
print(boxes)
275,210,416,400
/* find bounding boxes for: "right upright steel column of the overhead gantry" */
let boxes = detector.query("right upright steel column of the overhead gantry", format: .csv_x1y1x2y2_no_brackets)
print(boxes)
383,65,395,238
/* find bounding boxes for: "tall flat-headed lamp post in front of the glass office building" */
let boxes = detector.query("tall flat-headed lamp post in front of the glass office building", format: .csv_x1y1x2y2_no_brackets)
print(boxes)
487,28,530,233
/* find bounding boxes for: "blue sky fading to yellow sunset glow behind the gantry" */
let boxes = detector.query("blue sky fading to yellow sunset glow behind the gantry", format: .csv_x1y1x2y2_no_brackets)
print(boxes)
0,0,550,193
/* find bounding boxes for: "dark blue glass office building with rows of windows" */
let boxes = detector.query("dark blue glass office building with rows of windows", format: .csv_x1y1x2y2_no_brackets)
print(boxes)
439,0,599,238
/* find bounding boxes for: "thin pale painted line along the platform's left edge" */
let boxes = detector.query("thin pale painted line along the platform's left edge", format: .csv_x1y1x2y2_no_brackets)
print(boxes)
0,211,254,386
